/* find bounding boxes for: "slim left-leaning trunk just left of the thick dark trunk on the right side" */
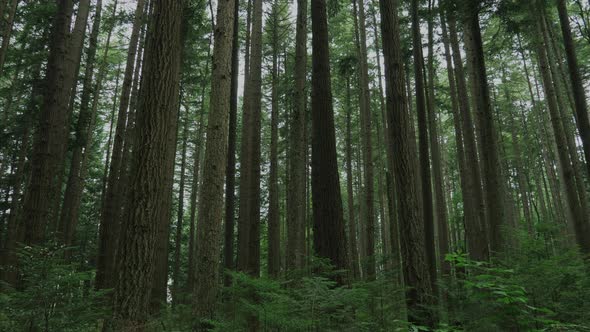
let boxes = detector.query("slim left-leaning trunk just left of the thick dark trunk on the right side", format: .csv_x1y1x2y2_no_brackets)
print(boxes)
448,11,489,261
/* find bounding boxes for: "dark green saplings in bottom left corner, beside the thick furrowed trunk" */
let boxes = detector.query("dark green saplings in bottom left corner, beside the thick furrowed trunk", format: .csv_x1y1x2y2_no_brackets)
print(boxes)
0,247,108,332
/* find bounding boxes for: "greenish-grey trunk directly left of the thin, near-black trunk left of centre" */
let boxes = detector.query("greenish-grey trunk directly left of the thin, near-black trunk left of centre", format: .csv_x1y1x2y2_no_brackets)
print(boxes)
193,0,235,322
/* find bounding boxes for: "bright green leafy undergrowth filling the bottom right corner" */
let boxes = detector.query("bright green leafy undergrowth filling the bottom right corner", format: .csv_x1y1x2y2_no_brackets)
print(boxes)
447,252,590,331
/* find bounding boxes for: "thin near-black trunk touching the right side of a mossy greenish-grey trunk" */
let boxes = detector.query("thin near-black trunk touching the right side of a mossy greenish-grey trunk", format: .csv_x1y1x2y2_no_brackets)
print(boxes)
223,1,240,286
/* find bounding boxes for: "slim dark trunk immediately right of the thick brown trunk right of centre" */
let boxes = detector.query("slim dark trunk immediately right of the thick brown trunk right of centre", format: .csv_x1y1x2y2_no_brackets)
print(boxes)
411,0,437,294
